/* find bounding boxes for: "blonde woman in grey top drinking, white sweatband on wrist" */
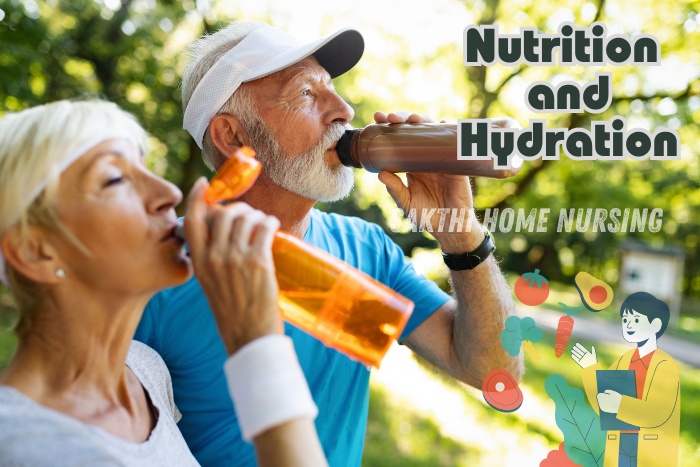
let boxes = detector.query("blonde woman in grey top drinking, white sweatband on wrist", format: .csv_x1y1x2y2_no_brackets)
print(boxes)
0,101,325,466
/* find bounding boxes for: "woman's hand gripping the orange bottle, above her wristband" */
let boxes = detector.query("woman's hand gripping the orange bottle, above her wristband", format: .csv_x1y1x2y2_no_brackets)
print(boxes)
185,178,282,355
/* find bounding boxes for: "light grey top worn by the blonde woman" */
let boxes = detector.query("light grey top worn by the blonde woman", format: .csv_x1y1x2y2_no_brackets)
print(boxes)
0,341,199,467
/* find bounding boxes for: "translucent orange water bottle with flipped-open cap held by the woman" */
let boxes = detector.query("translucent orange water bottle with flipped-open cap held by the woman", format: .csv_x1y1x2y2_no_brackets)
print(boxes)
187,147,413,367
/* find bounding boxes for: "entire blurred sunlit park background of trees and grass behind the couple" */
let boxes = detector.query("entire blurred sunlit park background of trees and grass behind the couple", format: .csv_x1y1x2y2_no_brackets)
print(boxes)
0,0,700,466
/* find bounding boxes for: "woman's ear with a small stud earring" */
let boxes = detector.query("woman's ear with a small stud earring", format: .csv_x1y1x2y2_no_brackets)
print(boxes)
0,227,61,284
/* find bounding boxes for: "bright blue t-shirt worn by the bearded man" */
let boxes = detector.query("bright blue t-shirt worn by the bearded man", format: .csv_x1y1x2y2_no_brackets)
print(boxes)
135,209,450,467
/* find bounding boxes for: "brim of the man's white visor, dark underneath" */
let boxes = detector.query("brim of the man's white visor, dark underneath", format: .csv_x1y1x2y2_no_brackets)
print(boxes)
243,29,365,82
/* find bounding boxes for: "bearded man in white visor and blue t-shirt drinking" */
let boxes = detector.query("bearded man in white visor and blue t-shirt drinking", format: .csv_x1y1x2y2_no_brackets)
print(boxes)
136,22,522,466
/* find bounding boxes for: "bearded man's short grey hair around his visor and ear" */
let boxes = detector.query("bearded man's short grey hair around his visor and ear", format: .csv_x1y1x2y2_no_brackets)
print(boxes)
182,21,264,170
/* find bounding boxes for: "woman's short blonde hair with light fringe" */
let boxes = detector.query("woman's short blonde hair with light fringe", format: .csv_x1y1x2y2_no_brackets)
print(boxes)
0,100,148,336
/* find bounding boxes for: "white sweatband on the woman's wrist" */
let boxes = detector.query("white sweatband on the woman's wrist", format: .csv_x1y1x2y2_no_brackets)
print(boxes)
224,334,318,441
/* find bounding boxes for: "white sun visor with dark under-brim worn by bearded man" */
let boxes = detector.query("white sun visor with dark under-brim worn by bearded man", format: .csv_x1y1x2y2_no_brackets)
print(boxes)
183,25,364,148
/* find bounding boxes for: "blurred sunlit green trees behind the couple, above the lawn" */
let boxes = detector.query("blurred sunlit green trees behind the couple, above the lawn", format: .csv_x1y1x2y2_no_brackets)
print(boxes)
0,0,700,298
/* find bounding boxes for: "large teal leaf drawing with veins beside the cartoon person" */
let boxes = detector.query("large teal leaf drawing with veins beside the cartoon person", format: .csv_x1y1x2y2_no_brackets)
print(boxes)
544,374,606,467
